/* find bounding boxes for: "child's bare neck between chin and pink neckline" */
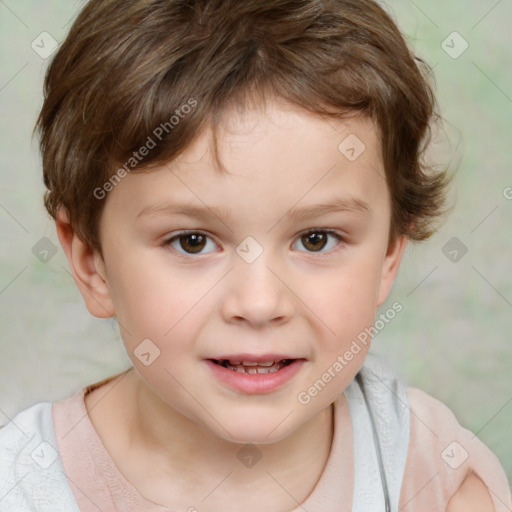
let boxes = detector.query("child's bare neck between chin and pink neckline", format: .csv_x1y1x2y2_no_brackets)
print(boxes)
130,371,334,512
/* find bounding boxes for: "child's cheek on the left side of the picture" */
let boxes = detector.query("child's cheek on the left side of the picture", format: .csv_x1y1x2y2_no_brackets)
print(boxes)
113,267,207,392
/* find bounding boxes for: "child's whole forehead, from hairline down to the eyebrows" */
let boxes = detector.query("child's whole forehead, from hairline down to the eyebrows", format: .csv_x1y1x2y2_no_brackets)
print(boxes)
101,102,389,228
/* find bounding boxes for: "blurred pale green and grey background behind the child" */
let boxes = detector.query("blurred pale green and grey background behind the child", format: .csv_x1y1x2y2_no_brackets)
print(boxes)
0,0,512,482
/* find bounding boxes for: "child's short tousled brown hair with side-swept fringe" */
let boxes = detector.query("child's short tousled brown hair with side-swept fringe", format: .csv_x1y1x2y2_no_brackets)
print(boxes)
35,0,447,253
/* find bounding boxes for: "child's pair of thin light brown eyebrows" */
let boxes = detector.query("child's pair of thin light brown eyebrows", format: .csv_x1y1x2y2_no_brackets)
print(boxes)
136,198,372,222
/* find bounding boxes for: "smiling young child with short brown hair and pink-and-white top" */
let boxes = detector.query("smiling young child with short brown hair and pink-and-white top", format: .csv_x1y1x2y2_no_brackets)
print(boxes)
0,0,512,512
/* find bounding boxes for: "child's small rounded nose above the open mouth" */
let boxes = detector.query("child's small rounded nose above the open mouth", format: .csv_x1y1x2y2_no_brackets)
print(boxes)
222,253,294,327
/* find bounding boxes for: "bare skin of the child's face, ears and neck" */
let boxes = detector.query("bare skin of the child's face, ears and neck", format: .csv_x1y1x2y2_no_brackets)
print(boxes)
57,101,490,512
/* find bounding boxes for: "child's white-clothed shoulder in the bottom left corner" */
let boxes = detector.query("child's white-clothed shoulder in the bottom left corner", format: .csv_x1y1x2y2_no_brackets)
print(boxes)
0,402,78,512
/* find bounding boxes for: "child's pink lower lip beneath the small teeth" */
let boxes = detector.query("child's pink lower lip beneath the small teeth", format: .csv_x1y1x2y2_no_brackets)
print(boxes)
206,359,306,395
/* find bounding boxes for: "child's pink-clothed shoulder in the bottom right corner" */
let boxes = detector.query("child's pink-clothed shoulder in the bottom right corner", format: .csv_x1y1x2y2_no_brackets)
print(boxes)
402,387,511,512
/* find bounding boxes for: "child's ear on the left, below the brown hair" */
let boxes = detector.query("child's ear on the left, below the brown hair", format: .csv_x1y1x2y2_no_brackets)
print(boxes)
55,206,115,318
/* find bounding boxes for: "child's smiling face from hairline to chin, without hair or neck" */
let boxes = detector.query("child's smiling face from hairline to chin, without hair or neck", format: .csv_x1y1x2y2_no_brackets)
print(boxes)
90,103,405,443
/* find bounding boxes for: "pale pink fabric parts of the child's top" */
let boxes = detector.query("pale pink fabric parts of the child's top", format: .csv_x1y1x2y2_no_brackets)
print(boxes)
52,375,512,512
